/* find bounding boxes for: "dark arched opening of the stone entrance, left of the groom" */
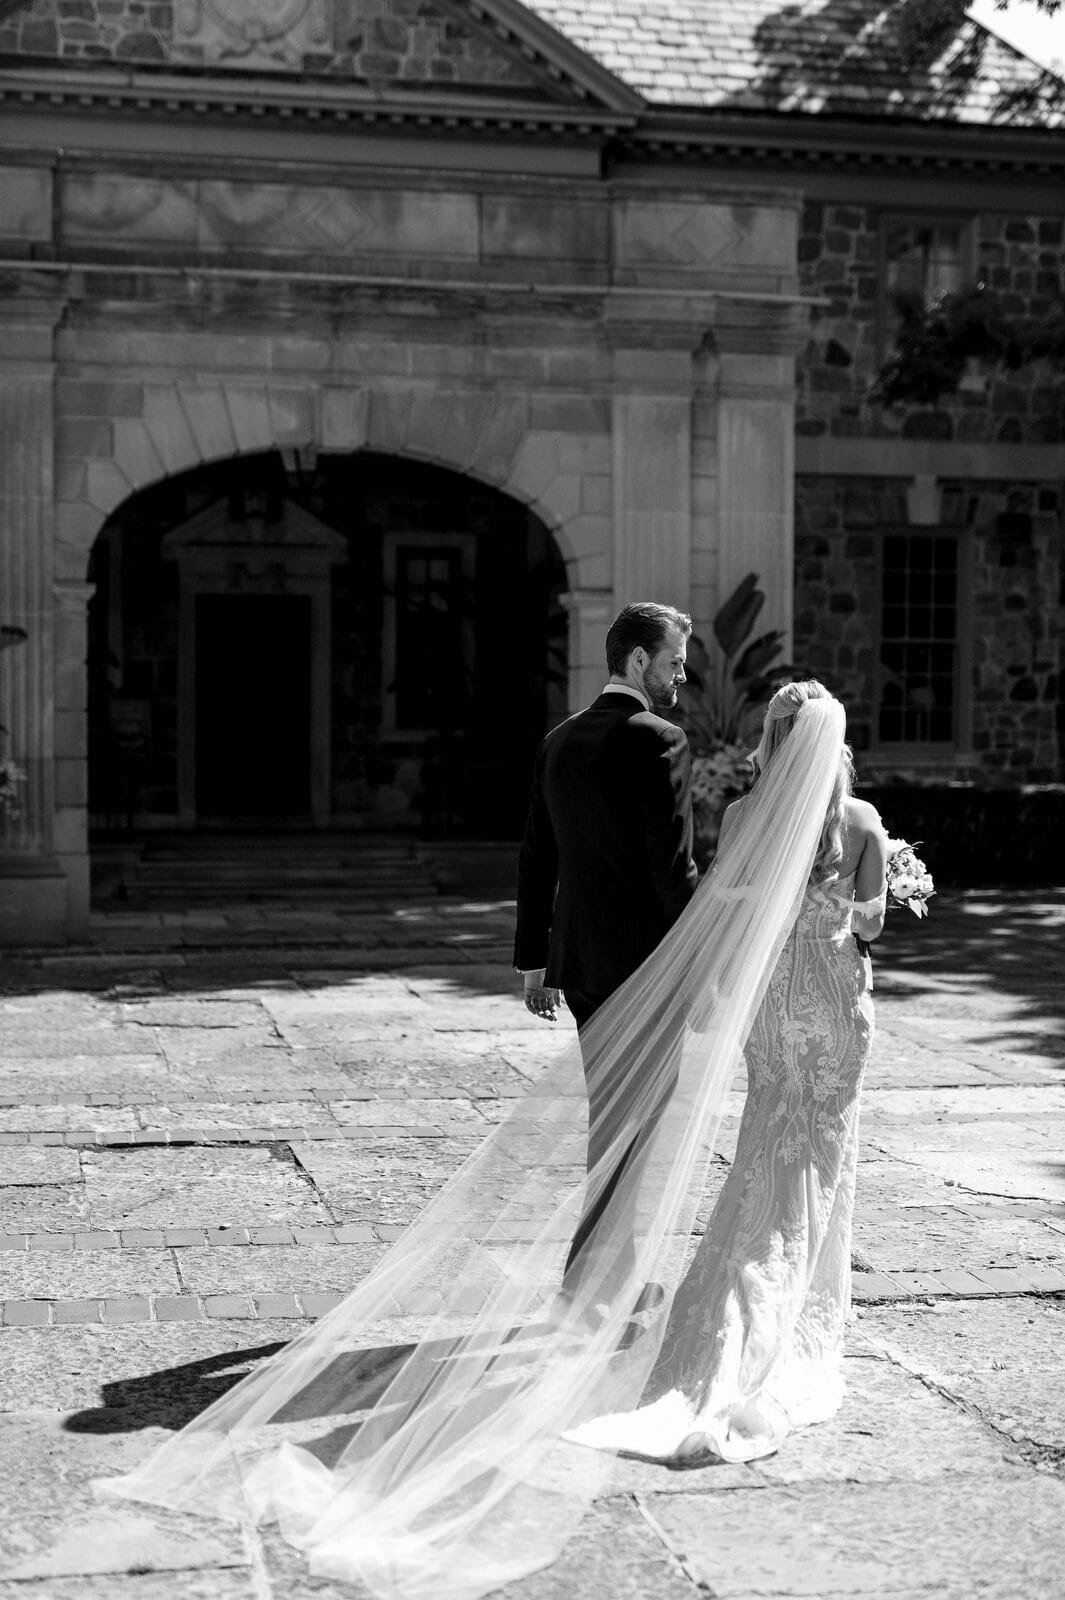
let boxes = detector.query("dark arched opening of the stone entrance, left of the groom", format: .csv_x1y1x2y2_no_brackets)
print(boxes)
88,453,566,838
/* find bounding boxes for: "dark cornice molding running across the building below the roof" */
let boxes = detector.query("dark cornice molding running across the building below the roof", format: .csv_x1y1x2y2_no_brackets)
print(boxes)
0,67,1065,172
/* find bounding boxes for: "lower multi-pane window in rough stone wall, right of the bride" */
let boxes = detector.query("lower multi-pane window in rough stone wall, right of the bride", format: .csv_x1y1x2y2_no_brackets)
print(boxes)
878,528,963,747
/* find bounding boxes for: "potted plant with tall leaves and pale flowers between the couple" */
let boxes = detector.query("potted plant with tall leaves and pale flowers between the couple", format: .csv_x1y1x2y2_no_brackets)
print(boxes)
675,573,795,870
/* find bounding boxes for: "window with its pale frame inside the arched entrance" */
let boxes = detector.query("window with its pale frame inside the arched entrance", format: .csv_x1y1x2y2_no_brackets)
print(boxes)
384,533,473,734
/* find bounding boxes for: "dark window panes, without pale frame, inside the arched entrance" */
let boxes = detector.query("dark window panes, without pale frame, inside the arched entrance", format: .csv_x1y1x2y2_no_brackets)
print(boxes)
395,544,467,728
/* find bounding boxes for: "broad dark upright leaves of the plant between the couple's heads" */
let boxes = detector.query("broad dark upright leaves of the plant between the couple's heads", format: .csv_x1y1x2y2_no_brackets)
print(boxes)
675,573,795,755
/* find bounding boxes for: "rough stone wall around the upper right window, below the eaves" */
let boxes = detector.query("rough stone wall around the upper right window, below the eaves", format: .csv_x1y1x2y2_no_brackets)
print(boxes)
796,203,1065,445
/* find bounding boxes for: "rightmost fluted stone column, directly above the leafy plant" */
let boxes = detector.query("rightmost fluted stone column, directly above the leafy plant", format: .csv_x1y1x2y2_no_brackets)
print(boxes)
718,336,795,650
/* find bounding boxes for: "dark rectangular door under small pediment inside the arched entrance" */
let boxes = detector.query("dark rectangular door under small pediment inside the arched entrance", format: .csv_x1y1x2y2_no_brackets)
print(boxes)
197,595,310,821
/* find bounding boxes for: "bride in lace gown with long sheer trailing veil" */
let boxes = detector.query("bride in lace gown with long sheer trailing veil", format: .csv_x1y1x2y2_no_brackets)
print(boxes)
102,683,886,1600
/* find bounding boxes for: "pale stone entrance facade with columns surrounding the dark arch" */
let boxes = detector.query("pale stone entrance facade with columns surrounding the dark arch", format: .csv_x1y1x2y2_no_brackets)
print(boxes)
0,134,800,938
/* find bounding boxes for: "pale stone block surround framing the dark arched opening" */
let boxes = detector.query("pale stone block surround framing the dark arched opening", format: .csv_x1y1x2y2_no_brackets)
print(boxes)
40,368,614,934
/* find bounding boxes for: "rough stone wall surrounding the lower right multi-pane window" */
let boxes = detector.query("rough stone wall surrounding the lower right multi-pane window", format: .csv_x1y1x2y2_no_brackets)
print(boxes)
795,477,1063,786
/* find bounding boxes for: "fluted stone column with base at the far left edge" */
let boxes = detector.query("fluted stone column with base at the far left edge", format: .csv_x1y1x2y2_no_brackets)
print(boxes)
0,301,67,946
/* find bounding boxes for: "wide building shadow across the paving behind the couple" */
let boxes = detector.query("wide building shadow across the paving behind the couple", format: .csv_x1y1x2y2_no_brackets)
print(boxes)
0,888,1065,1070
